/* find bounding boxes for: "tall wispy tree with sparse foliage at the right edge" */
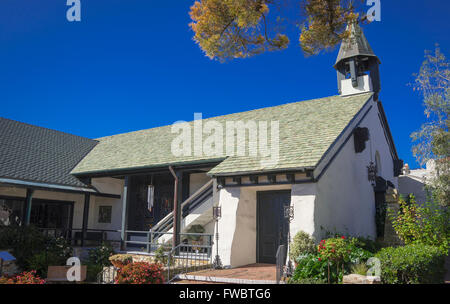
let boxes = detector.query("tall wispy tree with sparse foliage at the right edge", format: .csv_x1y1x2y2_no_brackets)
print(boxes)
411,46,450,206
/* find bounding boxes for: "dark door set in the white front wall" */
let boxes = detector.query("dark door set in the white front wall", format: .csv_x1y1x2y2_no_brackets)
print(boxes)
256,190,291,264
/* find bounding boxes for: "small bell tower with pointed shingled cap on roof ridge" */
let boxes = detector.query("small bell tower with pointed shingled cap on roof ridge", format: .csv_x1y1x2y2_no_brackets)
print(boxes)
334,22,381,100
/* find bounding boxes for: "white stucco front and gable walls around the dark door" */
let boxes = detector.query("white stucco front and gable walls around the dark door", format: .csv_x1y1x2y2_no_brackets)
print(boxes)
214,101,398,267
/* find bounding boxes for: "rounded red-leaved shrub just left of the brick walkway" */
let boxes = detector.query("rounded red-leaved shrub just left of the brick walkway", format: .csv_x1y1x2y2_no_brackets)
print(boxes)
115,262,164,284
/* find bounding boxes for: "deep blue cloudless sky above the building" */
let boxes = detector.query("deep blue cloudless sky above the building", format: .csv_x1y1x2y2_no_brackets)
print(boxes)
0,0,450,167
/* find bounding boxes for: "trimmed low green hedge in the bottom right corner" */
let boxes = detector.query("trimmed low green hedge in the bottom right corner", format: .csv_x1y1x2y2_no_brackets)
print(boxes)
376,244,446,284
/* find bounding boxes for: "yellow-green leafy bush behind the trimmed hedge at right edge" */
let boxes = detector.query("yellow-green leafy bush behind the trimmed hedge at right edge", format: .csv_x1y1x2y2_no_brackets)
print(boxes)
390,195,450,253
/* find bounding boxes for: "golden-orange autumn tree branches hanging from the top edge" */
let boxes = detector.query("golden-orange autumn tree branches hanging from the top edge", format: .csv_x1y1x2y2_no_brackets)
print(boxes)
190,0,367,61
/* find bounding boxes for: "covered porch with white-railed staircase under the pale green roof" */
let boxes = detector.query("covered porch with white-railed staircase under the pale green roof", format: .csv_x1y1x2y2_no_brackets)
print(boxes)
82,164,213,254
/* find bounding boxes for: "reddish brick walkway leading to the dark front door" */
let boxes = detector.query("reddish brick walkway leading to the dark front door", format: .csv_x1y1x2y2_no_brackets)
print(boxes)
180,264,276,283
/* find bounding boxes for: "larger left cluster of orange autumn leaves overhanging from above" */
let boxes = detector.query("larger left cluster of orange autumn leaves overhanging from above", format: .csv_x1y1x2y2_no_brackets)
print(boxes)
190,0,289,60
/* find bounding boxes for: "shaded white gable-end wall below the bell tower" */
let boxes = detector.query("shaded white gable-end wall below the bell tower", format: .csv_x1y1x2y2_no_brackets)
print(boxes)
314,102,398,238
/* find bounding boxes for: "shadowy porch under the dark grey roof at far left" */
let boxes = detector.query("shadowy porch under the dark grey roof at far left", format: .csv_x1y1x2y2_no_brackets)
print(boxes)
0,179,121,246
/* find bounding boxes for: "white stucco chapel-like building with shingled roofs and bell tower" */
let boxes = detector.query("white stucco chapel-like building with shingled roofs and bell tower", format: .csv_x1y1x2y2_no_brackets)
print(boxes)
0,25,403,267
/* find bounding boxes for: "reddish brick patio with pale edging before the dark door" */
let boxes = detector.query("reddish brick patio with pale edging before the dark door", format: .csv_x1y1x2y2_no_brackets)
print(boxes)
176,264,276,284
